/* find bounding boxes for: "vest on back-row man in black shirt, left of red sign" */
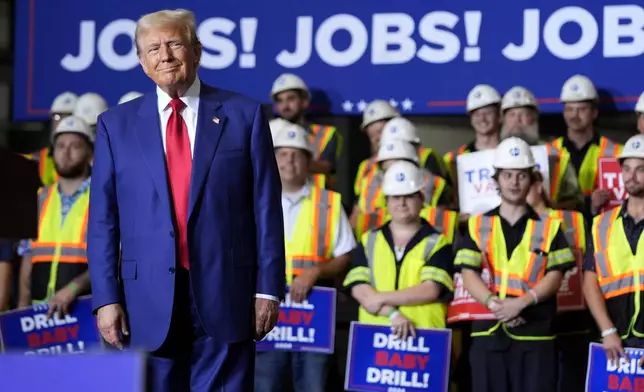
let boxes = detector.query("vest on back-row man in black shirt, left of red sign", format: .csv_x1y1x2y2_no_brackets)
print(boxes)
551,136,623,196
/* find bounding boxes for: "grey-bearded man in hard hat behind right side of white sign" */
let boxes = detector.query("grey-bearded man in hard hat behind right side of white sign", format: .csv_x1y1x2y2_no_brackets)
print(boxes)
501,86,584,210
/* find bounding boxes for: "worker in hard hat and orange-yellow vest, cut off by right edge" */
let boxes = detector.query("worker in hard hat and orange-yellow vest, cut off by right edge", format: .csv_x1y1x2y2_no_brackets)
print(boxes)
584,134,644,367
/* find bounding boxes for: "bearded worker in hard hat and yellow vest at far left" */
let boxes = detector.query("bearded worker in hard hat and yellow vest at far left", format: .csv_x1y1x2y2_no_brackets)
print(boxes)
18,116,94,316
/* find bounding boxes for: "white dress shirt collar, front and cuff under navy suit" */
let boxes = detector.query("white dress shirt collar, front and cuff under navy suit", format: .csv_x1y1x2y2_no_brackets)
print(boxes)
157,78,279,302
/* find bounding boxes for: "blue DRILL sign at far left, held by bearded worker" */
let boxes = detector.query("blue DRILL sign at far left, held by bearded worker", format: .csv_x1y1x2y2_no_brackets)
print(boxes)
0,296,102,355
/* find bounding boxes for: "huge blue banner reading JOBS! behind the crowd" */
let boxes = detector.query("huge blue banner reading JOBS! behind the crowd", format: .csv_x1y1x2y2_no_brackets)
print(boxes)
13,0,644,120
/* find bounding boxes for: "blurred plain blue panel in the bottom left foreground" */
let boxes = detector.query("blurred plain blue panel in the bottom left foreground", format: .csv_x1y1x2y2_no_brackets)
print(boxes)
0,351,146,392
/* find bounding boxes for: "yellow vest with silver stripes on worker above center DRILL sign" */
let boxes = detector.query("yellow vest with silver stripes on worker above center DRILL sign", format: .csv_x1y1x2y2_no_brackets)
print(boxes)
344,230,454,328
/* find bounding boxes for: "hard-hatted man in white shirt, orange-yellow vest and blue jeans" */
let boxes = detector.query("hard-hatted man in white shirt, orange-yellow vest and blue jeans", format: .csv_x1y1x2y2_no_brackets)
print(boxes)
255,124,356,392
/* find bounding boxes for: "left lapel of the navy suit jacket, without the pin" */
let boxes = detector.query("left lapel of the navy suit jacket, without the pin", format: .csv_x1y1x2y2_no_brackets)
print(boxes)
134,93,170,211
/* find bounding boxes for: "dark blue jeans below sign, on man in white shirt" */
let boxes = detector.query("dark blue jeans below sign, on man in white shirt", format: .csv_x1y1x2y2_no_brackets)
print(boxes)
255,350,330,392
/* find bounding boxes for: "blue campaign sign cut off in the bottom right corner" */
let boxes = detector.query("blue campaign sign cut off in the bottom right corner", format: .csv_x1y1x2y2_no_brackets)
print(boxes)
586,343,644,392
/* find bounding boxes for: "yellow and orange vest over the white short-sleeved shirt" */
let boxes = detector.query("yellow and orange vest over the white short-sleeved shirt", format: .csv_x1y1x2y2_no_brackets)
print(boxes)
284,186,342,285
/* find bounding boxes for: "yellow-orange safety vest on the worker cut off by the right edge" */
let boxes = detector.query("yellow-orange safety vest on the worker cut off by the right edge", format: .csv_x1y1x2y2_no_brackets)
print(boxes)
592,206,644,339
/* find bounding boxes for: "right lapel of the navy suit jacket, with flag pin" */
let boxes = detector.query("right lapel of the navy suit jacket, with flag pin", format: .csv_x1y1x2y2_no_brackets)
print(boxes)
188,84,226,219
